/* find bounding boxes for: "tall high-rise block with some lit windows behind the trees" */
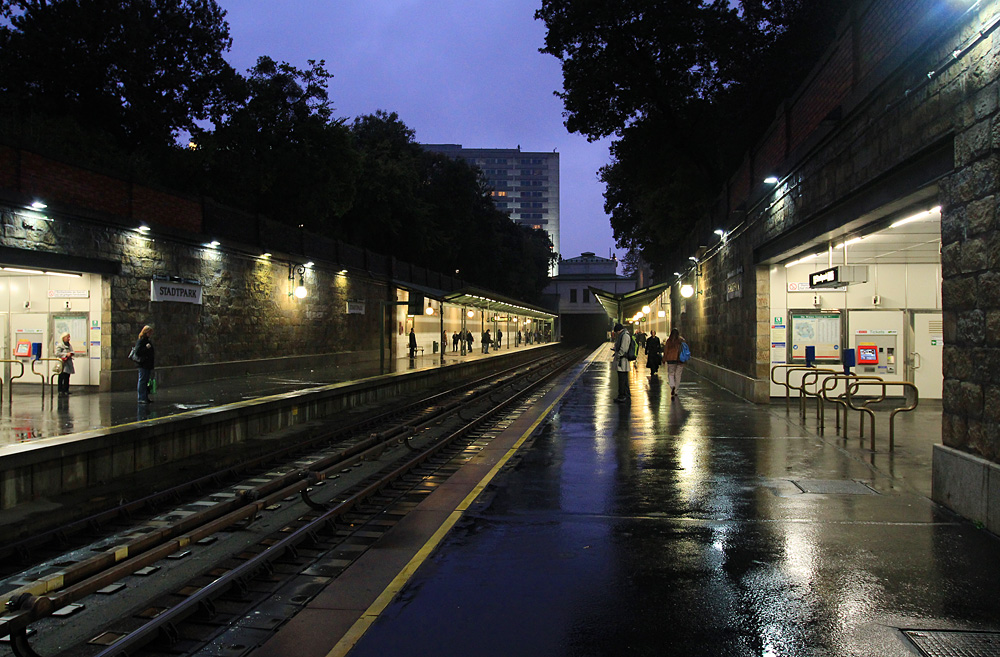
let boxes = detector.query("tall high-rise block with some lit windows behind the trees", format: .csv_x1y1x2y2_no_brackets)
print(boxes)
423,144,559,275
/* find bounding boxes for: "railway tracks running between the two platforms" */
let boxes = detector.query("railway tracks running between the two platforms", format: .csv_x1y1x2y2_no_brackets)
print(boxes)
0,352,582,657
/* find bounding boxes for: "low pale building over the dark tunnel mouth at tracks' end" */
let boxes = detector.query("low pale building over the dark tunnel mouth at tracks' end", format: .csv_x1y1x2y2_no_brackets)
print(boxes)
543,251,636,344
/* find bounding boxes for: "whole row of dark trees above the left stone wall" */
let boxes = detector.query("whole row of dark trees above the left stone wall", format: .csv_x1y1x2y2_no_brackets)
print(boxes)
0,0,553,301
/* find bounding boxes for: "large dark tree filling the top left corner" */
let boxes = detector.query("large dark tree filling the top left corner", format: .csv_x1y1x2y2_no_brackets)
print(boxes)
0,0,231,149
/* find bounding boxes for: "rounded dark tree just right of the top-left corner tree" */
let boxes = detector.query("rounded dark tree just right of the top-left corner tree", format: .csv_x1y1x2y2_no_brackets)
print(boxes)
194,57,358,233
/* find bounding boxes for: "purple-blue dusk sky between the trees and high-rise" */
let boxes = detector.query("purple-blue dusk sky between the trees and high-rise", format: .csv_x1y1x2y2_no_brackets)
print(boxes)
218,0,623,266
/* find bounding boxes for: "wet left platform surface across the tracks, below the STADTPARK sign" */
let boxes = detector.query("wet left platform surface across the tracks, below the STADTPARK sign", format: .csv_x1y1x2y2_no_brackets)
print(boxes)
0,345,541,448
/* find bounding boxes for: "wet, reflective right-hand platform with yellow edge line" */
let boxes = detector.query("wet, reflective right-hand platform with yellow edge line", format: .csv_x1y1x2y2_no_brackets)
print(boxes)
256,345,1000,657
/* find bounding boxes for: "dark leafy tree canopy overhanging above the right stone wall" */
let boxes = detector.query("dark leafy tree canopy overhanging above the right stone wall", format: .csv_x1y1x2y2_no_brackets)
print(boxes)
535,0,850,272
